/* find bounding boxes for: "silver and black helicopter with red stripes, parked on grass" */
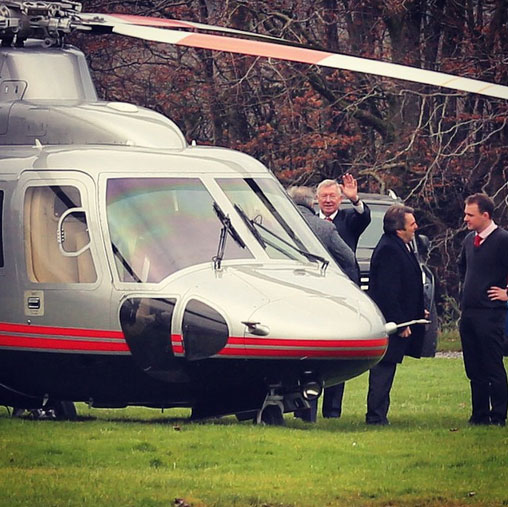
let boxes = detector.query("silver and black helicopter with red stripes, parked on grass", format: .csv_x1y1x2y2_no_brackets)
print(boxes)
0,1,508,424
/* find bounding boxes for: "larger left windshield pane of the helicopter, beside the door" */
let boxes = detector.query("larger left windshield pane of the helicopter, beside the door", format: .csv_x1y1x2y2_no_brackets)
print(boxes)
106,178,252,283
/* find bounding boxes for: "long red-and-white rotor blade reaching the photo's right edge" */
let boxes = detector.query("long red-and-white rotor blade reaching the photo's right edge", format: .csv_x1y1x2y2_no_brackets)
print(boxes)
81,14,508,100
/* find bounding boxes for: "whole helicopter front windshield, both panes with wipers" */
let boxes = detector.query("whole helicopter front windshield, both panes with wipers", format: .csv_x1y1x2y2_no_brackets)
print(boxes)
106,177,329,283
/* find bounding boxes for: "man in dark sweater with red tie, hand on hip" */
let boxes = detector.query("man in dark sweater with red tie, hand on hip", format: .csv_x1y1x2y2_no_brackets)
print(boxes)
459,193,508,426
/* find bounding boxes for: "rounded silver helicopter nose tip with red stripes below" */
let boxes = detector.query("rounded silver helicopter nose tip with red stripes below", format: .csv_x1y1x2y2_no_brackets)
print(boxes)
240,296,388,360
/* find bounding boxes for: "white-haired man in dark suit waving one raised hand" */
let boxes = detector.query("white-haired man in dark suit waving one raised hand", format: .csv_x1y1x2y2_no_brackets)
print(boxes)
316,174,371,417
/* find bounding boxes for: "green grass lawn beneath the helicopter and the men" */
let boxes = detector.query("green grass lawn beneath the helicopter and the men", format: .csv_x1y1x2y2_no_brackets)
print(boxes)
0,358,508,507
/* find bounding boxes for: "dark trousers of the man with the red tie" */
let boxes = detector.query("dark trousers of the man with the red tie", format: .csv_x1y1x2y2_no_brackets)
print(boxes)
459,309,508,424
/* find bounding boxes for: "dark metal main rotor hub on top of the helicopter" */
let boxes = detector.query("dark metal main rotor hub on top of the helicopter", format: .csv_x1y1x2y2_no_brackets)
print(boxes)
0,0,81,47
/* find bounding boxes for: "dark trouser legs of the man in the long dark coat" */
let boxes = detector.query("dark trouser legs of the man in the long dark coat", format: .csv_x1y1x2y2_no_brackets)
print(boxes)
365,361,397,424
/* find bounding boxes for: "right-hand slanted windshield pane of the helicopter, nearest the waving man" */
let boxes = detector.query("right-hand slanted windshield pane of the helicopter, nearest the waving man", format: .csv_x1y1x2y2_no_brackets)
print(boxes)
217,178,329,262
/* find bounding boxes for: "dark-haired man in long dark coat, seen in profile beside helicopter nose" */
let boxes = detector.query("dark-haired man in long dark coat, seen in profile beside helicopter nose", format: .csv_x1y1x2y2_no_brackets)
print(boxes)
365,204,428,425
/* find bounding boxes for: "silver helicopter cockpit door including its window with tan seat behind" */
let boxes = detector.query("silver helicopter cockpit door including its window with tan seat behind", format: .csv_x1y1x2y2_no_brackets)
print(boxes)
19,175,111,330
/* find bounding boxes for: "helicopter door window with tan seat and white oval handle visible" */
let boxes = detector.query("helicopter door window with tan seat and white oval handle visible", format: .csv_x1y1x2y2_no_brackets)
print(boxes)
24,186,97,283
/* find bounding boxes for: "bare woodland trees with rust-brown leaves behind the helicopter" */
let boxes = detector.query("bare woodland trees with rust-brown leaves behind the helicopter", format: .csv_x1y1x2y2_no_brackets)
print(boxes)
75,0,508,314
